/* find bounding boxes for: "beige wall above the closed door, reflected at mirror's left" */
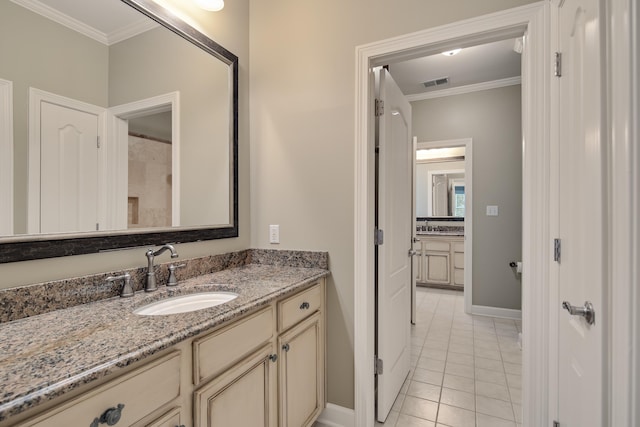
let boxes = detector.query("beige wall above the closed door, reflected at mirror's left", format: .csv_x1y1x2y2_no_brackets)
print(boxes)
0,0,108,234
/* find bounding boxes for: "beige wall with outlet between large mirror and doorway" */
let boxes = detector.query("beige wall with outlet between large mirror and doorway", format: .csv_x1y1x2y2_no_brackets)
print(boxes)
251,0,531,408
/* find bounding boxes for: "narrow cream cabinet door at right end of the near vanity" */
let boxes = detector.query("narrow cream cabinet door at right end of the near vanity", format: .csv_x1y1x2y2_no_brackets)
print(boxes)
278,313,324,427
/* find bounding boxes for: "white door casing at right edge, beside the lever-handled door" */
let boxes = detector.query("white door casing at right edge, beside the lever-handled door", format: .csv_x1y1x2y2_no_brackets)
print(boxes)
605,0,640,426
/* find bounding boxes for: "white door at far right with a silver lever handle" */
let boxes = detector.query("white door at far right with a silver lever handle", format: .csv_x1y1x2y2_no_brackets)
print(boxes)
557,0,607,427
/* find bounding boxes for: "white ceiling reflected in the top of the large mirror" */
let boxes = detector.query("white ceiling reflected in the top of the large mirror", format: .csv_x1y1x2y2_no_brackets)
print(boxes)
11,0,158,45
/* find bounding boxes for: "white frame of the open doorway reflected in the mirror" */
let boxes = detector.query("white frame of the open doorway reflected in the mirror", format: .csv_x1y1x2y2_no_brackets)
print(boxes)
108,91,180,228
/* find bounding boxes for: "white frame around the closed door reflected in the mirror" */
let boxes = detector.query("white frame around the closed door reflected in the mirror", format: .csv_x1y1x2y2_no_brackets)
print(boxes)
27,87,108,234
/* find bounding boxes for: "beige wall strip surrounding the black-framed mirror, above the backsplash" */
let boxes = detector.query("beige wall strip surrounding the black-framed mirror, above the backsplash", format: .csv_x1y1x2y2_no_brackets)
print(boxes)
0,0,250,288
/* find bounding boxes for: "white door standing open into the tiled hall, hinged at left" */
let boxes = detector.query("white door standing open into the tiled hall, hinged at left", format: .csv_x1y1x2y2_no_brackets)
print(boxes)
376,69,414,421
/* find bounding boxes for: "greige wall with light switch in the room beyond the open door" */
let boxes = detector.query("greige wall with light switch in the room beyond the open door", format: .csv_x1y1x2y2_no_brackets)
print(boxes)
411,85,522,310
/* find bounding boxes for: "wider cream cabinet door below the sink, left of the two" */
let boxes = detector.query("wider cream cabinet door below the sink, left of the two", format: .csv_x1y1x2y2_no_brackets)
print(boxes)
193,345,277,427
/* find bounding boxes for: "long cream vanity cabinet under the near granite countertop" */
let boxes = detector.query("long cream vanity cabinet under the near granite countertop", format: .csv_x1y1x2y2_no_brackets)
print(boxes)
11,279,326,427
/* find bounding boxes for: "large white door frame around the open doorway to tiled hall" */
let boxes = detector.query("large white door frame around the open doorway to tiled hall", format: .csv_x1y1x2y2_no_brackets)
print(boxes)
354,2,552,427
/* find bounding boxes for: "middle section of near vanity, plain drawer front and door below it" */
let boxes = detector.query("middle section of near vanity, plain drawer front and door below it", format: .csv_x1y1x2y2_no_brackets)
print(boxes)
193,306,277,427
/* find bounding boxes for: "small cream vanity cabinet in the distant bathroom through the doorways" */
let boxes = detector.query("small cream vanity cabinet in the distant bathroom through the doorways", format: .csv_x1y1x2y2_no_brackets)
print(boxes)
416,235,464,288
